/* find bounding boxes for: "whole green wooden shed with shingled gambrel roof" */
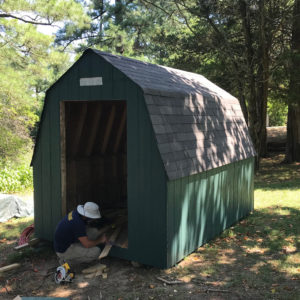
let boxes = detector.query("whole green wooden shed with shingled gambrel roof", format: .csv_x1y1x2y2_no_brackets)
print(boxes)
32,49,256,268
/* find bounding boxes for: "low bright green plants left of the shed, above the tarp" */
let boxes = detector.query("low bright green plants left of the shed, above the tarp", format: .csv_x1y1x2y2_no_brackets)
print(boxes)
0,164,33,193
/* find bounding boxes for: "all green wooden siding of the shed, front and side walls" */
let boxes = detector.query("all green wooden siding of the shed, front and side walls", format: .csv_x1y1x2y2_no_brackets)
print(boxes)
33,52,254,268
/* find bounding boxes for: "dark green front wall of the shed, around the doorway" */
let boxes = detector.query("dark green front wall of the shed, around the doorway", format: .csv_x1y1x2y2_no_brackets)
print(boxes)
33,53,167,267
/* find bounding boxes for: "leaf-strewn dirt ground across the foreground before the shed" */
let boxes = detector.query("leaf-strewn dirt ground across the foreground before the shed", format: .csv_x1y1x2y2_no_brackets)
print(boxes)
0,238,300,300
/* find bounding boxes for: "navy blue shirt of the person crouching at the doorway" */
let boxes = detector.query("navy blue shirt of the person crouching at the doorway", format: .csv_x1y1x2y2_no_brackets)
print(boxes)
54,209,86,253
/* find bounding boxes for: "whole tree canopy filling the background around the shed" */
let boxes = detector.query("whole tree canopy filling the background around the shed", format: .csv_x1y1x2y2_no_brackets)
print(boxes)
0,0,300,166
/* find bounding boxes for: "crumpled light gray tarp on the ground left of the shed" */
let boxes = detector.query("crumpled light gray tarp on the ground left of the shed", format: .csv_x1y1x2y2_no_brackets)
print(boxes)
0,194,33,222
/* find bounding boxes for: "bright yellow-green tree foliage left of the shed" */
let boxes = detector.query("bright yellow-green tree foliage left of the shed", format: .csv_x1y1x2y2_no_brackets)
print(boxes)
0,0,89,162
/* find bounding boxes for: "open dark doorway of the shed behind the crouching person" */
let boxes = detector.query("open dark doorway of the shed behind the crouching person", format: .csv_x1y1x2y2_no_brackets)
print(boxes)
61,101,128,248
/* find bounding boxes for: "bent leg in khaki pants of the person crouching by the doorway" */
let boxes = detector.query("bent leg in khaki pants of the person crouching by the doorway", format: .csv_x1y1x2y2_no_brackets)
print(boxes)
57,243,101,265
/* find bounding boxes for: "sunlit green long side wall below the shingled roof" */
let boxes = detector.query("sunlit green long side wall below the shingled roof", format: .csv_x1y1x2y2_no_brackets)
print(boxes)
167,158,254,267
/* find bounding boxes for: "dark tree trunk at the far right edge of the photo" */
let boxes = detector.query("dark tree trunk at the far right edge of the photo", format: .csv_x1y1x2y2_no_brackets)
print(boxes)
285,0,300,163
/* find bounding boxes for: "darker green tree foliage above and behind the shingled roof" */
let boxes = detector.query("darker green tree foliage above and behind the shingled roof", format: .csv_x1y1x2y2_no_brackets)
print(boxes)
56,0,293,148
